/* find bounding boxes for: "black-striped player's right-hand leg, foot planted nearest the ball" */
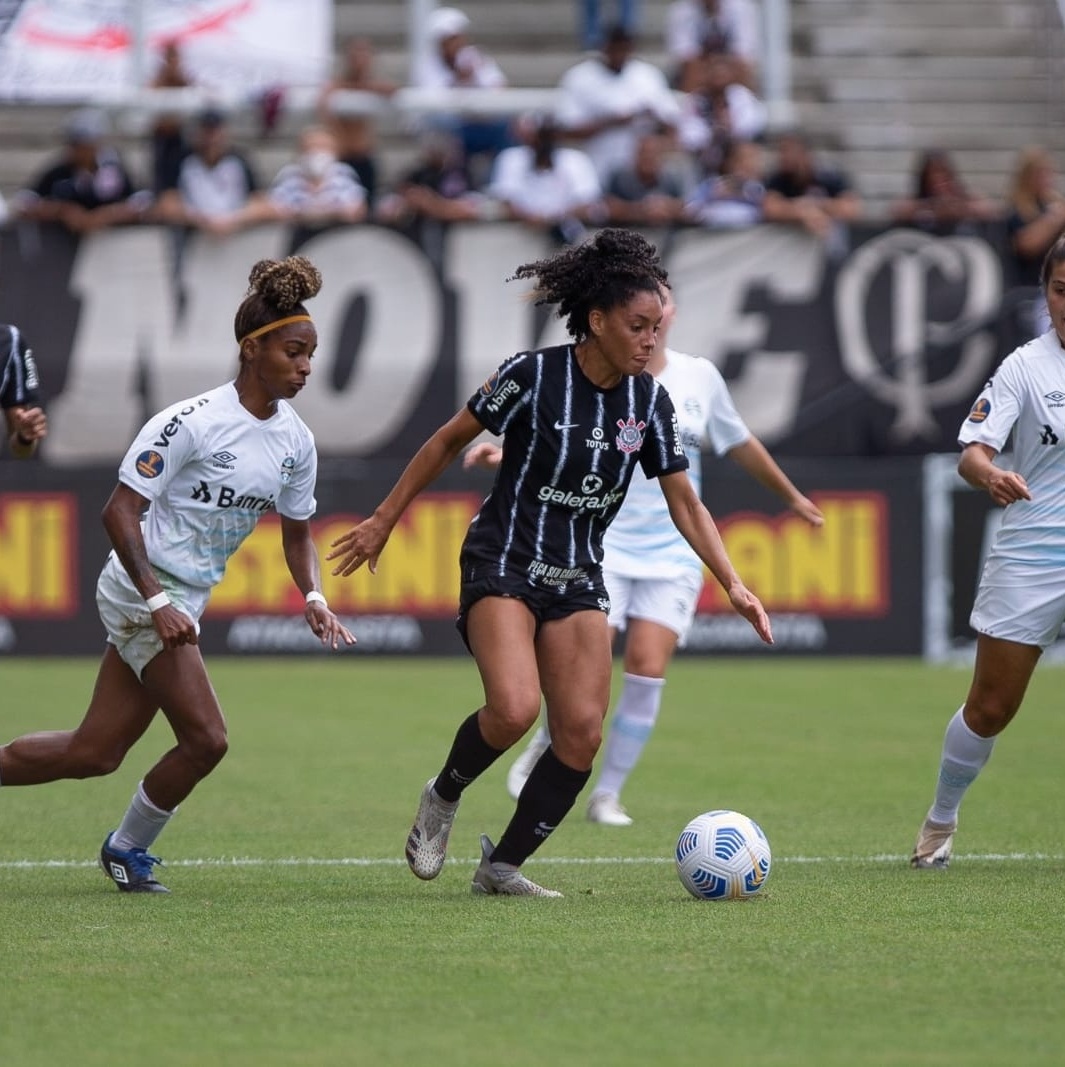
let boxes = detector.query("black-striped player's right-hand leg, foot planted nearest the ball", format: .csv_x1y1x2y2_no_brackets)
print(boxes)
473,610,610,896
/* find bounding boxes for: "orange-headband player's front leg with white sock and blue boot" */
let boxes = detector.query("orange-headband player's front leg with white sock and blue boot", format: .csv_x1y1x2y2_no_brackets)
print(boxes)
100,644,227,892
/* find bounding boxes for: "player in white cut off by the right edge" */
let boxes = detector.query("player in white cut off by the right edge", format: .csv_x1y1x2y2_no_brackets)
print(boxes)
910,231,1065,869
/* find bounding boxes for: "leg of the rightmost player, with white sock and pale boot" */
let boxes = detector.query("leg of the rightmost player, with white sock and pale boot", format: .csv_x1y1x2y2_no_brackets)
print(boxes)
910,634,1042,869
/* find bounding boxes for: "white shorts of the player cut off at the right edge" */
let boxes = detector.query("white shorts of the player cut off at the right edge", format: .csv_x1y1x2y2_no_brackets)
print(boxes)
969,559,1065,649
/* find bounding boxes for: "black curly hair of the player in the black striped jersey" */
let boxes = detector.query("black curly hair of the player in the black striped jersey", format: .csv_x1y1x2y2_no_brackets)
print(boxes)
507,229,669,344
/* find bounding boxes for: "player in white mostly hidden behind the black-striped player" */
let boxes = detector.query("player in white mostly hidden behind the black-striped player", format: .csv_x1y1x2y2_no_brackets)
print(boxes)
484,286,824,826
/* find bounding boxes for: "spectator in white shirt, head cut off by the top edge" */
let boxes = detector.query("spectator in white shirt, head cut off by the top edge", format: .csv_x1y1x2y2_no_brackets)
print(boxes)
666,0,762,92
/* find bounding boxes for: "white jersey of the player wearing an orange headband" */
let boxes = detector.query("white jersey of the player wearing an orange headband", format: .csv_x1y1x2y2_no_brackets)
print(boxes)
118,382,318,589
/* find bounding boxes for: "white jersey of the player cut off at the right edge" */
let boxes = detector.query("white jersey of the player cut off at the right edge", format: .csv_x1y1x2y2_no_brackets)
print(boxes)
958,330,1065,578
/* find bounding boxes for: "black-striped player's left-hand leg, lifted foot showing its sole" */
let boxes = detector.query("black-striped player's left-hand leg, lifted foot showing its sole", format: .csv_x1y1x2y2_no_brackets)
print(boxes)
406,595,540,879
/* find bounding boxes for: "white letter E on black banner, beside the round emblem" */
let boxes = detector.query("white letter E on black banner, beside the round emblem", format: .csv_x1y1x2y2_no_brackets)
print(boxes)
667,226,824,443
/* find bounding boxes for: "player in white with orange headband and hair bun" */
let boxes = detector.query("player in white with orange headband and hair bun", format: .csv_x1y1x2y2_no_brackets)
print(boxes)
0,256,354,893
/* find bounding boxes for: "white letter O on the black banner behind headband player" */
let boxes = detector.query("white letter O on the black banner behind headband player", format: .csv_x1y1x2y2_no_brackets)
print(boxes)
285,226,439,453
